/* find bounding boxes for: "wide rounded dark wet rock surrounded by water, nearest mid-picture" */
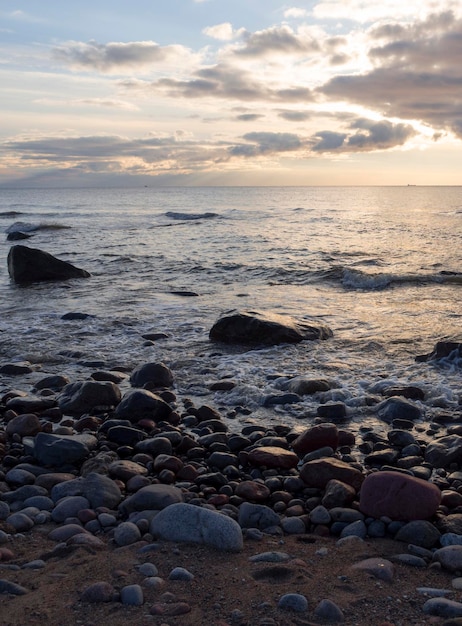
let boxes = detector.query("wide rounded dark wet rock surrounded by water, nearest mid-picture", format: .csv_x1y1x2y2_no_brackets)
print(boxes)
209,311,333,346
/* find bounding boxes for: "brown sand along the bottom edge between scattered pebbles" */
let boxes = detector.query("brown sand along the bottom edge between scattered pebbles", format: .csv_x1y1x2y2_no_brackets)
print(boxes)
0,526,454,626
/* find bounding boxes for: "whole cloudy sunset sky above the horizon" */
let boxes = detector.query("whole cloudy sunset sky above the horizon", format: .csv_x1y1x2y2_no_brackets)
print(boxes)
0,0,462,188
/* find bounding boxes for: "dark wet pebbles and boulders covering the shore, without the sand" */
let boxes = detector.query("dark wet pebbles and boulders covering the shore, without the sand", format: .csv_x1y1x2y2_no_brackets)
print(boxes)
0,356,462,623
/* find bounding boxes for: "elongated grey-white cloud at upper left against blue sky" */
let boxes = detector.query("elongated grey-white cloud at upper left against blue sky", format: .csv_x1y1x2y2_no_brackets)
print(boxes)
52,41,197,72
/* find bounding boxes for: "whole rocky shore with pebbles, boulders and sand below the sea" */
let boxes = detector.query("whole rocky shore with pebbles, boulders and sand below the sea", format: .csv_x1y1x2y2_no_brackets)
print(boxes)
0,330,462,626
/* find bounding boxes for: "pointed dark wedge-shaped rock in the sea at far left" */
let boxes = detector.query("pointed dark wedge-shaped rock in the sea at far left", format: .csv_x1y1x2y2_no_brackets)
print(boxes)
8,245,90,284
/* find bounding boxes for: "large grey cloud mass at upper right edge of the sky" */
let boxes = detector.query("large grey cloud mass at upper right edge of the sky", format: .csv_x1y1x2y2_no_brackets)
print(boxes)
319,12,462,137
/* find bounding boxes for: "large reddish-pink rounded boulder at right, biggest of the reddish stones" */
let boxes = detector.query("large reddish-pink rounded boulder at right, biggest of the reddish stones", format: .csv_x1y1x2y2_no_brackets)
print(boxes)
360,471,441,521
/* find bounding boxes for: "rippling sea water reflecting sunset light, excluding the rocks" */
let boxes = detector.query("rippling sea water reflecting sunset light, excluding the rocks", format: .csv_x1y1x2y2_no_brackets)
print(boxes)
0,186,462,430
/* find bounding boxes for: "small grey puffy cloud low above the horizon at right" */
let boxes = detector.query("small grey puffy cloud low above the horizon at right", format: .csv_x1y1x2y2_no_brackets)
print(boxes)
311,118,416,152
